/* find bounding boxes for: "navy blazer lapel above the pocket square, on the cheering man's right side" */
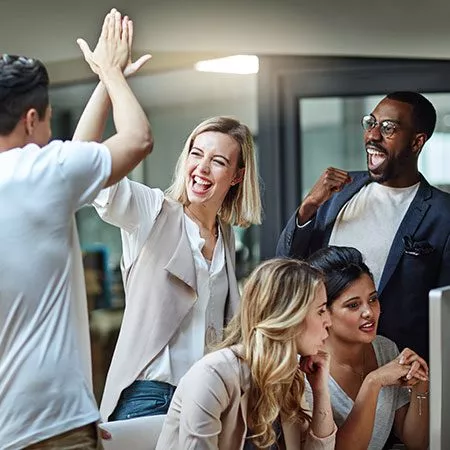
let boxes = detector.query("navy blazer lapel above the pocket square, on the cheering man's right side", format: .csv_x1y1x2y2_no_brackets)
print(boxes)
378,176,431,295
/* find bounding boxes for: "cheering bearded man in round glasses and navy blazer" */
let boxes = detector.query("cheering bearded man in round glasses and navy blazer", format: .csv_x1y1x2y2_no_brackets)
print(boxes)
277,92,450,366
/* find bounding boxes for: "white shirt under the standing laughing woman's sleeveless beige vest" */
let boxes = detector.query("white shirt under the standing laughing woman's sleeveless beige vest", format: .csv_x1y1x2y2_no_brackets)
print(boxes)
94,178,228,386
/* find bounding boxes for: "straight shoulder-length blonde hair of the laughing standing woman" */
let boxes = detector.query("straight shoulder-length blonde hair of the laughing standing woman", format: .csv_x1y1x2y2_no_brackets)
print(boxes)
166,117,261,228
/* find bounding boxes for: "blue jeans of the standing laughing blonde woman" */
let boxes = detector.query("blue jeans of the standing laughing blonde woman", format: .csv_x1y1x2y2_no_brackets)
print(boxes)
108,380,175,422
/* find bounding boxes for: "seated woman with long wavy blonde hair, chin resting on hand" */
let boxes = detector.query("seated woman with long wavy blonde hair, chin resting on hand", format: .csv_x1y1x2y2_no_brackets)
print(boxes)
157,259,336,450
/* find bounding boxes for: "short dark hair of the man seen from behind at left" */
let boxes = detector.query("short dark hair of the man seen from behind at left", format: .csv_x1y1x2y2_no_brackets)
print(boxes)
0,54,49,136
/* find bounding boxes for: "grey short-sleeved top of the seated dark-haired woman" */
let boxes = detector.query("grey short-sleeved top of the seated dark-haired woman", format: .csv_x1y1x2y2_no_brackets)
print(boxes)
305,336,410,450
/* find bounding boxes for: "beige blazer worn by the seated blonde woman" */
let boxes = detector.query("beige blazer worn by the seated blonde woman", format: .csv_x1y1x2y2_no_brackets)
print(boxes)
156,348,336,450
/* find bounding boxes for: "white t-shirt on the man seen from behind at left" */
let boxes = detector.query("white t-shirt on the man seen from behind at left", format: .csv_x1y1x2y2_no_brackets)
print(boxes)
0,141,111,450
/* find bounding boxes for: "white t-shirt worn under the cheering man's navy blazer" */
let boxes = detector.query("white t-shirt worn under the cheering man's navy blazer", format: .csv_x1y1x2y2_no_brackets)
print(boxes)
329,183,420,289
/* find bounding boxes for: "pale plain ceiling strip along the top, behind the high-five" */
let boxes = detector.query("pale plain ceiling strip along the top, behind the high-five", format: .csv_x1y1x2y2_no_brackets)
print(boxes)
4,0,450,62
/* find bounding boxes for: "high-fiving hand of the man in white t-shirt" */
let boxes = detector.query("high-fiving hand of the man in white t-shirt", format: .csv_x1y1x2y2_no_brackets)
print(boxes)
77,9,130,76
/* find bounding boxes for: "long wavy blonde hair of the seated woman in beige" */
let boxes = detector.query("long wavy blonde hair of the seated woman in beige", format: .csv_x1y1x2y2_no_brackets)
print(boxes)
220,258,323,448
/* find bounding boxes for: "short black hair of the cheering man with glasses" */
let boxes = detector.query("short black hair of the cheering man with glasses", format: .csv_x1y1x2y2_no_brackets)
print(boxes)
386,91,436,140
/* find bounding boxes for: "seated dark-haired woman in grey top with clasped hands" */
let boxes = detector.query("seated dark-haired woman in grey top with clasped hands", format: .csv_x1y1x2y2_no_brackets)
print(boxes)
307,246,428,450
